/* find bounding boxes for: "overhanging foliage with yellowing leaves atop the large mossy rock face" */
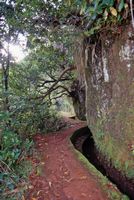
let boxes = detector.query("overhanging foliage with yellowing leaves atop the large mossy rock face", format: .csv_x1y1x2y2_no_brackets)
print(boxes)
70,0,129,36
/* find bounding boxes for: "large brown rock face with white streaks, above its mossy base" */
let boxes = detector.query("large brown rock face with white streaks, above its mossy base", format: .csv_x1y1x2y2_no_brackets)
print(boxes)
85,25,134,175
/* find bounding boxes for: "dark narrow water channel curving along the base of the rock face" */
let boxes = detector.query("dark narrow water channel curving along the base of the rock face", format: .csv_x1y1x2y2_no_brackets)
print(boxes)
71,127,134,200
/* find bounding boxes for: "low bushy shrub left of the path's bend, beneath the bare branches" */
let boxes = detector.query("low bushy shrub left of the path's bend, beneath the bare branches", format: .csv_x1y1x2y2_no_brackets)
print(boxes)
7,97,63,134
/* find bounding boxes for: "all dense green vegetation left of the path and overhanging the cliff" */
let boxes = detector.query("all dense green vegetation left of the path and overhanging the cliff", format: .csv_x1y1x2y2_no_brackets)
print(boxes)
0,0,133,200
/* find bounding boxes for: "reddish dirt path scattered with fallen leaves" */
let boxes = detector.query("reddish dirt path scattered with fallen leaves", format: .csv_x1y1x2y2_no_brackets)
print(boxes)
26,120,107,200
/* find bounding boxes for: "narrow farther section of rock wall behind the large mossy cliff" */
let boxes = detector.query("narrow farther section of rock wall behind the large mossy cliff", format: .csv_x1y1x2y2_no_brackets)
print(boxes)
70,37,86,120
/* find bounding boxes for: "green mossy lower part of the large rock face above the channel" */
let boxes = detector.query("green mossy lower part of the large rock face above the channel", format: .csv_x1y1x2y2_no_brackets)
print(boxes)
90,111,134,178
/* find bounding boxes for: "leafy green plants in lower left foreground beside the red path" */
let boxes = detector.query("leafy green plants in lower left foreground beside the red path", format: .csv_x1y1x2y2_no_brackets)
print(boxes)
0,130,33,199
